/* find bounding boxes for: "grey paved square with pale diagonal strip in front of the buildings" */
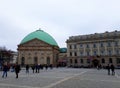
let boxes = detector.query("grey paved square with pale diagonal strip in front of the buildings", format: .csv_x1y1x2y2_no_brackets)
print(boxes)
0,68,120,88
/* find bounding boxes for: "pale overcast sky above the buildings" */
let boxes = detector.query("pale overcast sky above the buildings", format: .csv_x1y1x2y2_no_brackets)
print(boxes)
0,0,120,51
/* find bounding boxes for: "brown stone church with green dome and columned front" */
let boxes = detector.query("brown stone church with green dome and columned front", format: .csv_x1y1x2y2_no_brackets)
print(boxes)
17,29,59,66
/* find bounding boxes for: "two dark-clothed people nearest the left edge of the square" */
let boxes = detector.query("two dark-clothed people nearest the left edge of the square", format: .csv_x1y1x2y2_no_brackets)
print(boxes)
2,63,20,78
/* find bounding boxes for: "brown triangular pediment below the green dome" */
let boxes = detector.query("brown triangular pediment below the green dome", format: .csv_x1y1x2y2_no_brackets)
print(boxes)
21,38,51,47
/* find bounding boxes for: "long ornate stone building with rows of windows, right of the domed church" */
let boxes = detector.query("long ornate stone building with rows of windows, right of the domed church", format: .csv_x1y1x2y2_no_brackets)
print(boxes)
66,31,120,67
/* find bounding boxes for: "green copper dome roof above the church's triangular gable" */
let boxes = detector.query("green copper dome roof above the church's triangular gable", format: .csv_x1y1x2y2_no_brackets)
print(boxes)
20,30,58,46
